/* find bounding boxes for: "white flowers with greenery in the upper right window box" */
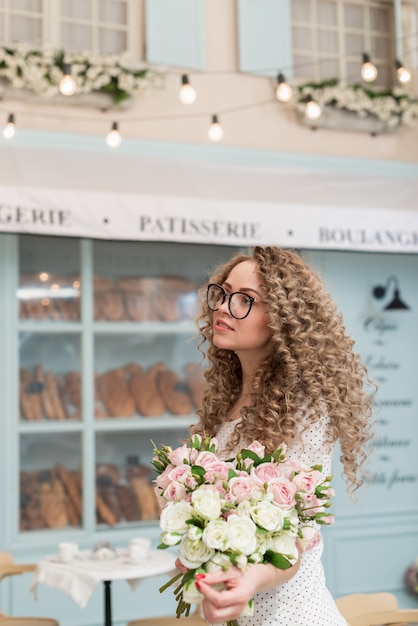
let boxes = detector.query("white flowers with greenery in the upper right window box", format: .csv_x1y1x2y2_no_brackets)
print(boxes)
290,79,418,128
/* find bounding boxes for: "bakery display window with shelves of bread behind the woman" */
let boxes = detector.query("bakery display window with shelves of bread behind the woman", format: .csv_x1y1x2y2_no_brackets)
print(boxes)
15,235,242,536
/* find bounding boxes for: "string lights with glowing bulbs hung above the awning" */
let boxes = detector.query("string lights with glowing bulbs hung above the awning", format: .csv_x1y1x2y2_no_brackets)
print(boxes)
3,33,418,148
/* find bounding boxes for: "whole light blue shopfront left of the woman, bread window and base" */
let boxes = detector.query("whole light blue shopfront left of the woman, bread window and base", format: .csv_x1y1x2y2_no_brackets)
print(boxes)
0,234,242,626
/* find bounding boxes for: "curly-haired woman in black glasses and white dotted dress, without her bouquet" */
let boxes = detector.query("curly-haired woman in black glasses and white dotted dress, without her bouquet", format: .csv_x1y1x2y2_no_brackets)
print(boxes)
185,246,372,626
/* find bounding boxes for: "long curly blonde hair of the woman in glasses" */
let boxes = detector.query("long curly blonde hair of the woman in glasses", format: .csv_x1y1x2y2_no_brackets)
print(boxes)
192,246,375,492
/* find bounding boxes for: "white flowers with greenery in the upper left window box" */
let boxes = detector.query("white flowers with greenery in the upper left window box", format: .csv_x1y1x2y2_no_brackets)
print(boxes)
0,44,162,104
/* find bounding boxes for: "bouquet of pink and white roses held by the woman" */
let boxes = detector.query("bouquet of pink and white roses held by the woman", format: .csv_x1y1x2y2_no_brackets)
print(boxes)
152,435,334,617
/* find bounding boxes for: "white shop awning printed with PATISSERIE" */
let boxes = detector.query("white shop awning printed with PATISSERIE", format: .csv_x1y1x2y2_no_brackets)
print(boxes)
0,133,418,253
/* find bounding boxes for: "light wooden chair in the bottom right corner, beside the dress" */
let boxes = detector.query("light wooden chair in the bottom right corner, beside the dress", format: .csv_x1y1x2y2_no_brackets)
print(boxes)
336,592,418,626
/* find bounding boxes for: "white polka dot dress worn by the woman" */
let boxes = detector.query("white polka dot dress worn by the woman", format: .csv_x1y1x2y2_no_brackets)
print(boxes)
216,414,347,626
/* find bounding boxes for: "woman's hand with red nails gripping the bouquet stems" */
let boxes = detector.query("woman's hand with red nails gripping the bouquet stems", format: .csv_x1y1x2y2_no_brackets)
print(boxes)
196,559,300,624
